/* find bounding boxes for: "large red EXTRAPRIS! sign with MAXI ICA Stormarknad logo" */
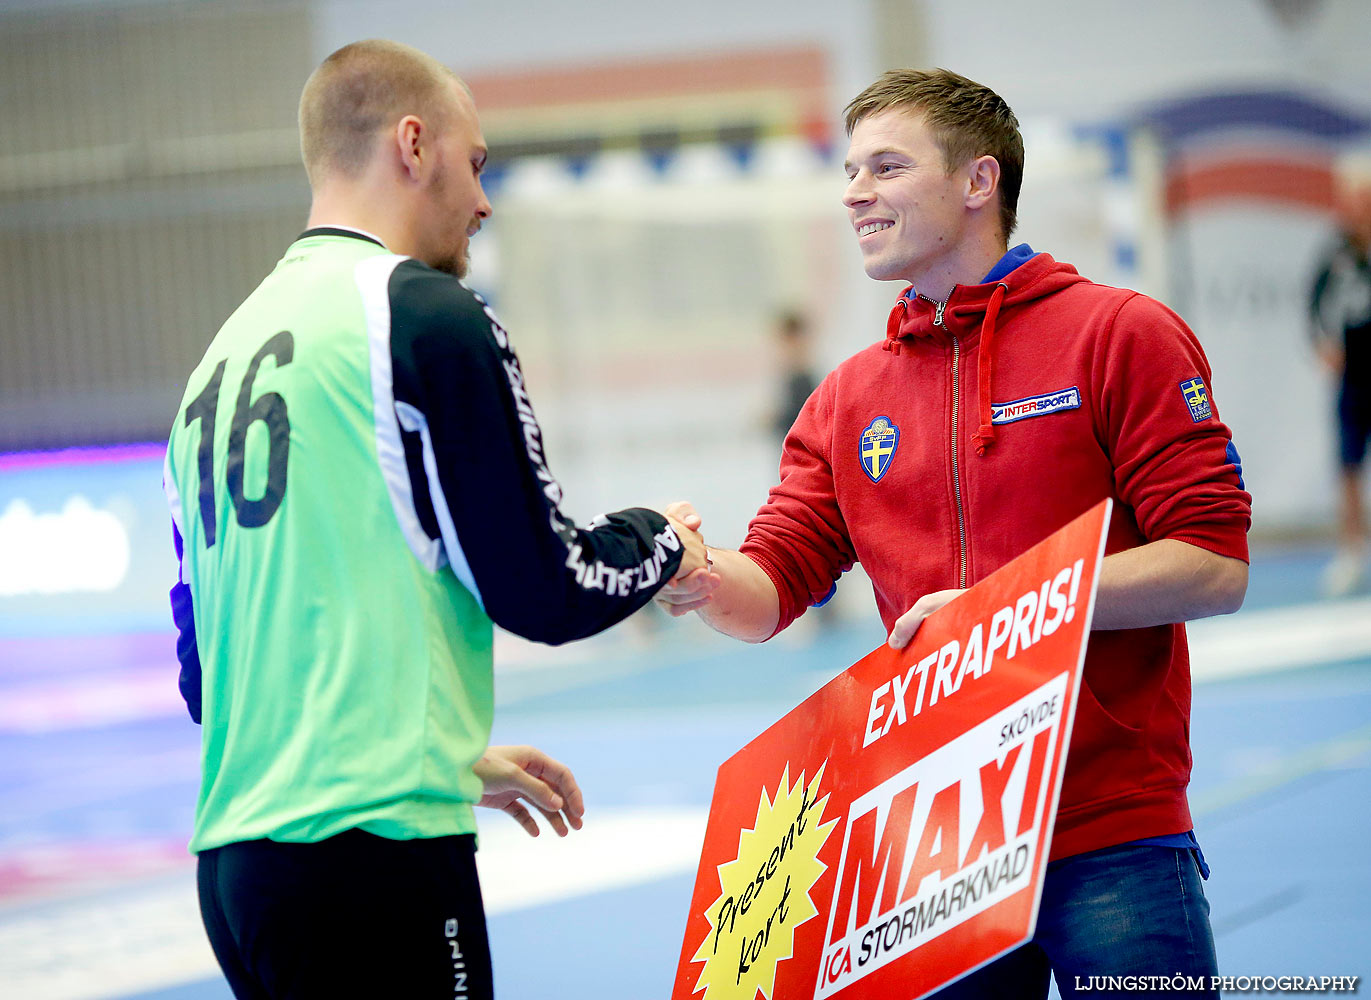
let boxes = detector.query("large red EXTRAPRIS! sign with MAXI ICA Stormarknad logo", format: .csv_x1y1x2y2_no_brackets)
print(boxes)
672,501,1111,1000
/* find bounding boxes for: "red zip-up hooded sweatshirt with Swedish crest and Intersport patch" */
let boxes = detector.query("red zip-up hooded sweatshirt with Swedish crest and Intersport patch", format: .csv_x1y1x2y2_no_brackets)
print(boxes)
742,254,1252,859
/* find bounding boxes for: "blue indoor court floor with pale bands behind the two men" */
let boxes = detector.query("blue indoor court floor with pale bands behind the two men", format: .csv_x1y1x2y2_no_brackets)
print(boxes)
0,549,1371,1000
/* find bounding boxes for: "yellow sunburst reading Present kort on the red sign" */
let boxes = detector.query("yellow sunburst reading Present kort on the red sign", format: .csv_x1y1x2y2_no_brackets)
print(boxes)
691,760,838,1000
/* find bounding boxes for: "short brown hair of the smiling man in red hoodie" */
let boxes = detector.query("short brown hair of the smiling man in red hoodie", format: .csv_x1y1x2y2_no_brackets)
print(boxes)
843,69,1024,241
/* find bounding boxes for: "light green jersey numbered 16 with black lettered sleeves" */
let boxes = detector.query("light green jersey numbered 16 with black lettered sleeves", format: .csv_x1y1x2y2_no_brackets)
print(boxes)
165,229,680,850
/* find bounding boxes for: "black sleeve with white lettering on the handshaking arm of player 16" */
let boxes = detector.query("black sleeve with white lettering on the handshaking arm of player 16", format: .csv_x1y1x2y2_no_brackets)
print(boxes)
394,262,705,645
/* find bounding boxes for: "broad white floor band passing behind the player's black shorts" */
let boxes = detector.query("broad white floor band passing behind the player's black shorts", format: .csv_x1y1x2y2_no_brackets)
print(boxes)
0,807,707,1000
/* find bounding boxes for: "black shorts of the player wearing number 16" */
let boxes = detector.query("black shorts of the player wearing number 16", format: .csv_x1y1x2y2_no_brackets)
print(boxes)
197,830,492,1000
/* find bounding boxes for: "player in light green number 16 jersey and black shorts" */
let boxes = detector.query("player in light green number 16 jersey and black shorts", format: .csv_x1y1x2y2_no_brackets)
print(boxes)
165,41,707,999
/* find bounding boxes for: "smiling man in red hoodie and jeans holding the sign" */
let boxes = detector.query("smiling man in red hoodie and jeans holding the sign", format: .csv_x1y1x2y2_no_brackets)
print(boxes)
658,70,1252,997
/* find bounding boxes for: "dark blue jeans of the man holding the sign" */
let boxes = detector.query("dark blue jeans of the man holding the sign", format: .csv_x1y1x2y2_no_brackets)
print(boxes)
934,845,1219,1000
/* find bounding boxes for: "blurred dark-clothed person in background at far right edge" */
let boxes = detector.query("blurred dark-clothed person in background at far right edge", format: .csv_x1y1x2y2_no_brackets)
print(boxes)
1309,155,1371,597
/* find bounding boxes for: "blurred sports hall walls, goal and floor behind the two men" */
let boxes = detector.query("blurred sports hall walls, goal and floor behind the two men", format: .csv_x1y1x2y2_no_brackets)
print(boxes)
0,0,1371,1000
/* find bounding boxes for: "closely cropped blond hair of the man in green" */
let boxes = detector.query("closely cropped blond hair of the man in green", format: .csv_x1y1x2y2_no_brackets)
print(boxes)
300,38,461,184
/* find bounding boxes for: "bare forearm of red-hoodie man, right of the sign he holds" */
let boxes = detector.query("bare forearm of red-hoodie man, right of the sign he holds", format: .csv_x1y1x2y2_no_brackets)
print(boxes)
1093,538,1248,630
